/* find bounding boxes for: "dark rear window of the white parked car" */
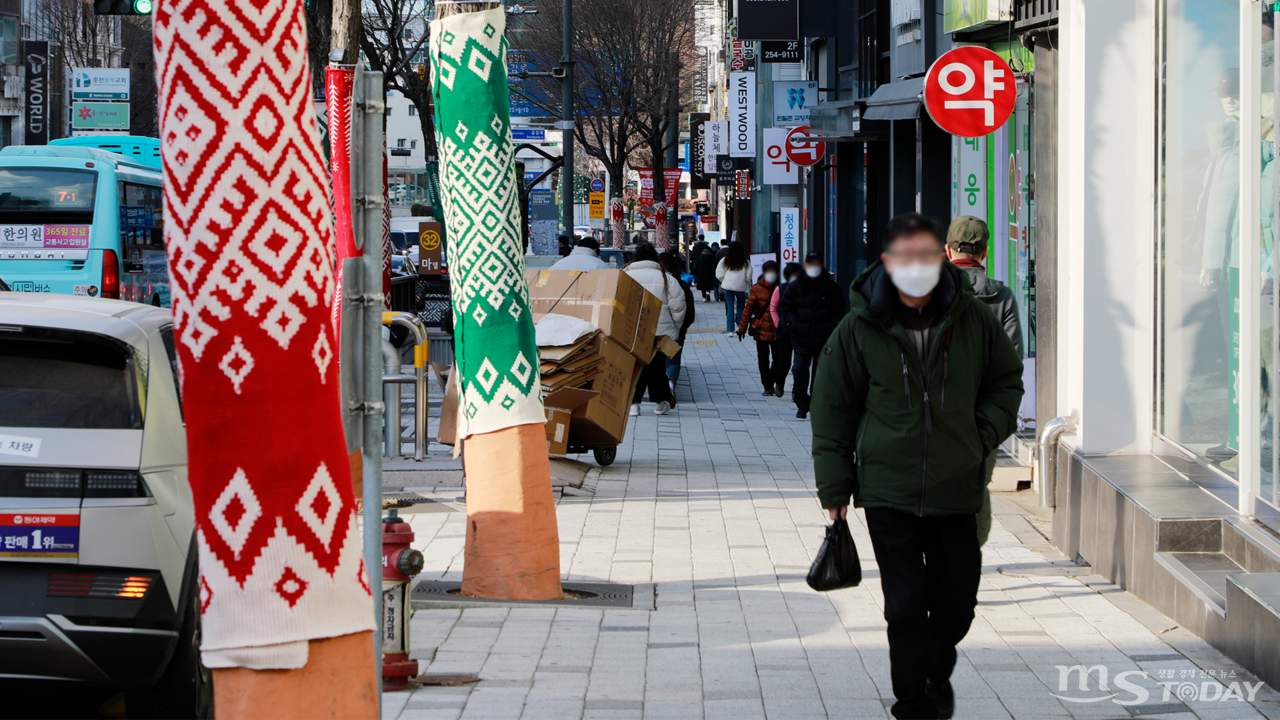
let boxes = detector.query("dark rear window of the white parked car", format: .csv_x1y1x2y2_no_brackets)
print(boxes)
0,327,146,429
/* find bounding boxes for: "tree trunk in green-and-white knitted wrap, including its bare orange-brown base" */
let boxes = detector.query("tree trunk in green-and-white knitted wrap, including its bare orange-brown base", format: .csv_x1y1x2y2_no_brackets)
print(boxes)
431,5,572,600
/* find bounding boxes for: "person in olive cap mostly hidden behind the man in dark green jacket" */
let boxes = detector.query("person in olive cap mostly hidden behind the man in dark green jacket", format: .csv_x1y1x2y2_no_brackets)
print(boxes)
947,215,1023,546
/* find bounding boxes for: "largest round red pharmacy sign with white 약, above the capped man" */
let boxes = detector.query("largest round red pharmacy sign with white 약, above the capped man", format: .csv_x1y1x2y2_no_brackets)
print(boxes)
924,46,1018,137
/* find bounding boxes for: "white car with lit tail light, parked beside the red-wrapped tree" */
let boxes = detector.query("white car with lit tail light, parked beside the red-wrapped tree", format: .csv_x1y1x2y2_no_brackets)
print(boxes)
0,292,212,720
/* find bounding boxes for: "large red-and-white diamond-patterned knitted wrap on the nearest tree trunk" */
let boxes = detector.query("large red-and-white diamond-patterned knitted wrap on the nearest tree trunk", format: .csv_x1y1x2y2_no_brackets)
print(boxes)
155,0,372,651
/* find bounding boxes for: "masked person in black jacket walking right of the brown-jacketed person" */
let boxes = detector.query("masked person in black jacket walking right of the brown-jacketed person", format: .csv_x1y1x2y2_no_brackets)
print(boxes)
778,252,845,419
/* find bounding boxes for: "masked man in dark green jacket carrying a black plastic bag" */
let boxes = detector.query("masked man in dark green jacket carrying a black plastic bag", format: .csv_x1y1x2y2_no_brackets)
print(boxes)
813,213,1023,720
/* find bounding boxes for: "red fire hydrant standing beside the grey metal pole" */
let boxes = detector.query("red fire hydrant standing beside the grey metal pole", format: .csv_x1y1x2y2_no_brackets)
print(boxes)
381,510,422,691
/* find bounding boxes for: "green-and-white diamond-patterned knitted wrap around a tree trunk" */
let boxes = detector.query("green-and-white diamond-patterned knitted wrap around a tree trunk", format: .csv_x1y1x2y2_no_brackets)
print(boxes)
431,6,544,438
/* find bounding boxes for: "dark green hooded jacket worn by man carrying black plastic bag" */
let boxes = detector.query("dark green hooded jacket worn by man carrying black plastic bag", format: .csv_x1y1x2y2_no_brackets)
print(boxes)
810,257,1023,516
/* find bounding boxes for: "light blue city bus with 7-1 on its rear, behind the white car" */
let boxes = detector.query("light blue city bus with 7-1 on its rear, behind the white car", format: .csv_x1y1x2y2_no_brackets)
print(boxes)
0,136,169,306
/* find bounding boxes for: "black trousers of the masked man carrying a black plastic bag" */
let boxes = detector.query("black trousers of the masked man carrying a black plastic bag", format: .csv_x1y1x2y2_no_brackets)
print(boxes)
867,507,982,720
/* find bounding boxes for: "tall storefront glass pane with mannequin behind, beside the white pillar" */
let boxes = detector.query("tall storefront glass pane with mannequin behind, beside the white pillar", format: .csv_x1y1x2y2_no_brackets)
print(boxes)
1156,0,1240,477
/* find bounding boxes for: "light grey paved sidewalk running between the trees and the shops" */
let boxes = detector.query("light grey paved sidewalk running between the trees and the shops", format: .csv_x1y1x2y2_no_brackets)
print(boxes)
383,302,1280,720
